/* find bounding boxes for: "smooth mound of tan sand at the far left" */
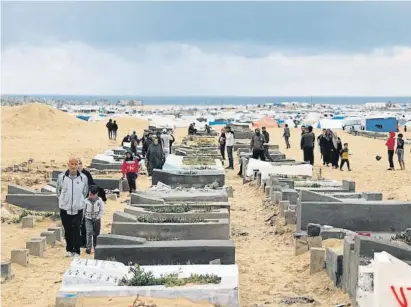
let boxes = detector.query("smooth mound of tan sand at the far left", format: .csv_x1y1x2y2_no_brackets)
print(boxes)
2,103,87,133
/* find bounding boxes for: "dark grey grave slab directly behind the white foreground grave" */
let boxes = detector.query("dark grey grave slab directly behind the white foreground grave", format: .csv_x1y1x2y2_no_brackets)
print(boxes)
95,240,235,265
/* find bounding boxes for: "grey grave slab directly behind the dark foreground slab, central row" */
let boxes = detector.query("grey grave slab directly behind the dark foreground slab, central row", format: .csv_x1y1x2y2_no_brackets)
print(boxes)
111,219,230,240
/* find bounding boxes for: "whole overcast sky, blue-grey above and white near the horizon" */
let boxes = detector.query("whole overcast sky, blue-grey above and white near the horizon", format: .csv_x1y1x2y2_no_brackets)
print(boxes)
1,1,411,96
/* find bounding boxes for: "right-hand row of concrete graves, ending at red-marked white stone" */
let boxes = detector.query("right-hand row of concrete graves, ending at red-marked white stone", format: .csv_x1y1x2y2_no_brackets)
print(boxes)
243,148,411,307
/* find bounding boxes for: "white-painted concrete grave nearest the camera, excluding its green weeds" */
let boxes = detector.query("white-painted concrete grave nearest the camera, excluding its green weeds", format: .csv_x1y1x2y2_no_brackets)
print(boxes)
56,265,240,307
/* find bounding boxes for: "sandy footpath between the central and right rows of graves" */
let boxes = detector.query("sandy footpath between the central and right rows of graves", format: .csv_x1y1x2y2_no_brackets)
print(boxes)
226,171,349,307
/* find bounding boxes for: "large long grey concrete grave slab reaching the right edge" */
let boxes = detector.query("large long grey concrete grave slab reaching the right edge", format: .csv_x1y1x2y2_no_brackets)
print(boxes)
297,201,411,232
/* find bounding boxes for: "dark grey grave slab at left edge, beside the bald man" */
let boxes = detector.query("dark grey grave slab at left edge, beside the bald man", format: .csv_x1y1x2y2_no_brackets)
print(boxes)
6,194,59,212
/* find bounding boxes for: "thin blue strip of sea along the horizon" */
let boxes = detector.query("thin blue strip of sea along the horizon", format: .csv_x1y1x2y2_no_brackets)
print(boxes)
1,94,411,105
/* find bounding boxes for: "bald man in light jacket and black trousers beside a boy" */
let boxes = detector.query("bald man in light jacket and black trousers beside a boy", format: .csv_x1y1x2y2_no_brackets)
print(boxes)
56,157,88,257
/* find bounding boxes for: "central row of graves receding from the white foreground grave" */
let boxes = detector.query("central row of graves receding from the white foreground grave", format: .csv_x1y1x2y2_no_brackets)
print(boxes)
56,136,240,307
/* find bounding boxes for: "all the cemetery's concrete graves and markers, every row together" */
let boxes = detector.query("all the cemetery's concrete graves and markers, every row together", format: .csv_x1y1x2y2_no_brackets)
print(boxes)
1,126,411,307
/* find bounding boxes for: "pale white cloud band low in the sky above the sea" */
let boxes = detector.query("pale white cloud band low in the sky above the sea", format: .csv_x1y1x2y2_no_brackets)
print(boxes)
1,42,411,96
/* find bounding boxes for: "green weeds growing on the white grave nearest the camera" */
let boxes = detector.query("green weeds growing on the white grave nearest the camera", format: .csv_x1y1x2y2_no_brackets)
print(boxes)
119,265,221,287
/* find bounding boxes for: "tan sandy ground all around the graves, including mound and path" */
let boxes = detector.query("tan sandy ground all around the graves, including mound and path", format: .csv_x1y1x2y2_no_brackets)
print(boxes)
1,105,411,307
